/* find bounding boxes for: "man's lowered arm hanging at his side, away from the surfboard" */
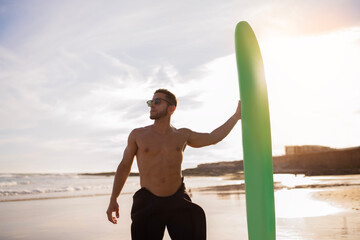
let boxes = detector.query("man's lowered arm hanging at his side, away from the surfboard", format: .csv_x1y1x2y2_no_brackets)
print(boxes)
106,130,137,224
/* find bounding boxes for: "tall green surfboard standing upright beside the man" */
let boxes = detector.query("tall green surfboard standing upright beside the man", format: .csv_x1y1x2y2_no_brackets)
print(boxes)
235,22,276,240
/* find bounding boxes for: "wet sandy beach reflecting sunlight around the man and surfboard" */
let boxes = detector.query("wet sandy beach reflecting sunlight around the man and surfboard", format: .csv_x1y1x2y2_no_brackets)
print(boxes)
0,175,360,240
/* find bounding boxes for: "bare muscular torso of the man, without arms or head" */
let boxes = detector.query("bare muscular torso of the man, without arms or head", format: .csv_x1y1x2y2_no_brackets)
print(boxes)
134,126,190,196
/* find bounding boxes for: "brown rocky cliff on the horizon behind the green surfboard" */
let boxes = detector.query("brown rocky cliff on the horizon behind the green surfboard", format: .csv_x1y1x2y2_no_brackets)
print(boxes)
183,146,360,176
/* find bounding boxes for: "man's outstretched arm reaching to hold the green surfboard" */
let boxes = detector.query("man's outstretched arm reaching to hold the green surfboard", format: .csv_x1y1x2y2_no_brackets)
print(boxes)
187,101,241,148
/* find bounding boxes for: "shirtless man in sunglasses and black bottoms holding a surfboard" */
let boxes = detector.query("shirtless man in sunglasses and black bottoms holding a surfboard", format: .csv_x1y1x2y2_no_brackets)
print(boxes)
106,89,241,240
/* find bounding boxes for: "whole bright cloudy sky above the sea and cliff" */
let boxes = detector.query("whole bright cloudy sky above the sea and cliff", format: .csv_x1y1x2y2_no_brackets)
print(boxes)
0,0,360,173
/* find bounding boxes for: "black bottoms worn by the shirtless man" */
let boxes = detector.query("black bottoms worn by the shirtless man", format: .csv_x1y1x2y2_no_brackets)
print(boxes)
131,183,206,240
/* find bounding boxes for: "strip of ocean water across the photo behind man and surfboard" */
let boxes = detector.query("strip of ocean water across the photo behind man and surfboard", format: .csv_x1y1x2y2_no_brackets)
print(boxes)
0,173,360,202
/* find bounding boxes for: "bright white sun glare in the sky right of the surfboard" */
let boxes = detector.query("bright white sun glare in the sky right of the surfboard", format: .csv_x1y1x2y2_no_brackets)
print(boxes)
261,29,360,146
